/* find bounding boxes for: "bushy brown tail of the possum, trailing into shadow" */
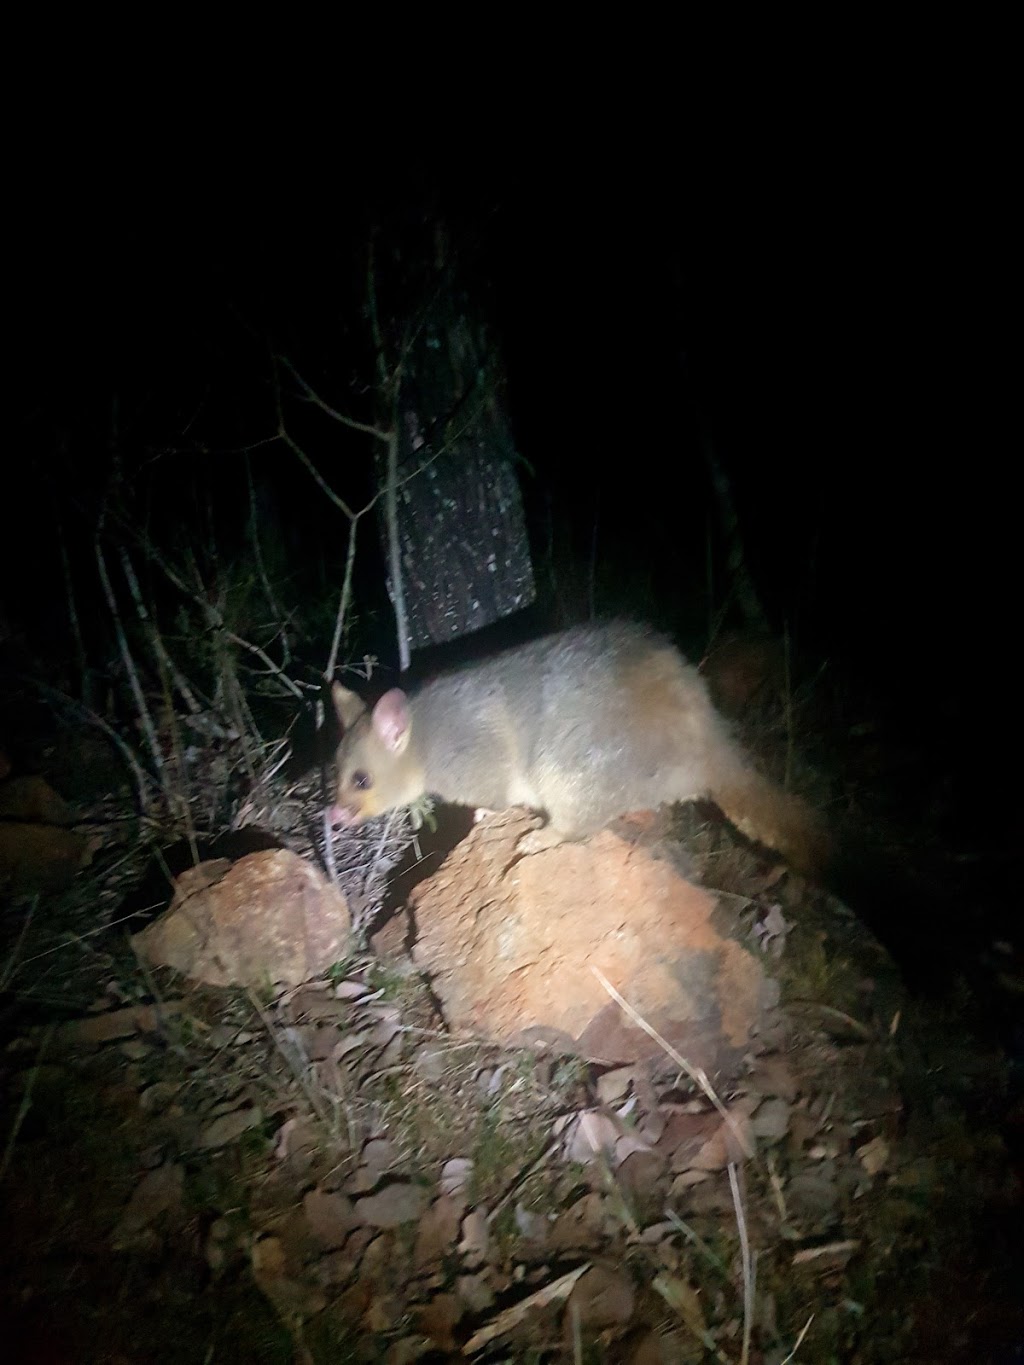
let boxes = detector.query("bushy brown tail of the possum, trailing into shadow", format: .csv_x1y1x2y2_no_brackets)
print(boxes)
709,764,830,878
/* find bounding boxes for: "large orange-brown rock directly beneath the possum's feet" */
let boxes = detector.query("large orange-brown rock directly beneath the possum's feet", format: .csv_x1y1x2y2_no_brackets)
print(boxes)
414,812,778,1077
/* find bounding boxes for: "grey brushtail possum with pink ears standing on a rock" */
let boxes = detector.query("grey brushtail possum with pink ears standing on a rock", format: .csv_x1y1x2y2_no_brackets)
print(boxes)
332,622,823,872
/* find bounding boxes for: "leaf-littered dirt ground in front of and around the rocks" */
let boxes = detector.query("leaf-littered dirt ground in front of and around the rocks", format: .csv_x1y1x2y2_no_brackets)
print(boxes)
0,737,1024,1365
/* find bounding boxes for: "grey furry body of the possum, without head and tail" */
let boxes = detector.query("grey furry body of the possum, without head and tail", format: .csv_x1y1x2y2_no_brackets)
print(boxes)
419,622,733,835
